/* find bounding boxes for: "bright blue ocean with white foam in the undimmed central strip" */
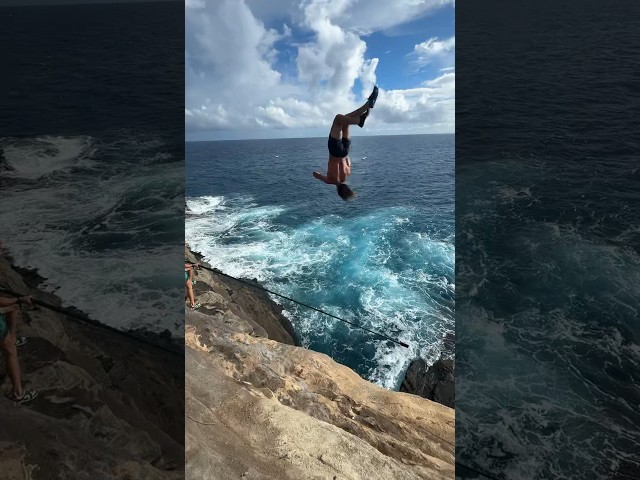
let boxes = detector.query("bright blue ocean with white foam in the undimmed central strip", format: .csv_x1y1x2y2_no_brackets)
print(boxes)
185,135,455,389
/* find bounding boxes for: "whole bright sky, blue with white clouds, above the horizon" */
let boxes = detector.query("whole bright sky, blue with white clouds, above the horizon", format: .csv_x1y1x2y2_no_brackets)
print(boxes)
185,0,455,140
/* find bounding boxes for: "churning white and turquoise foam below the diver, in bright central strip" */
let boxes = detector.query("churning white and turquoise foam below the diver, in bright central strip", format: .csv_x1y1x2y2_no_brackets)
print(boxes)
185,197,453,388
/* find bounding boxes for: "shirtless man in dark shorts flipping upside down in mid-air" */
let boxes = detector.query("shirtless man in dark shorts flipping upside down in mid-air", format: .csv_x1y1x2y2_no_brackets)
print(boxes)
313,87,378,201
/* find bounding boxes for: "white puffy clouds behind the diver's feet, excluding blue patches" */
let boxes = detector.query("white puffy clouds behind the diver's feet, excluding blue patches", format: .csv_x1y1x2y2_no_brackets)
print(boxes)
185,0,455,138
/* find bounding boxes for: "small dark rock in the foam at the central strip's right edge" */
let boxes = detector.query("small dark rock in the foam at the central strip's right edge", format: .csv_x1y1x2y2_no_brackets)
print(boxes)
400,358,455,408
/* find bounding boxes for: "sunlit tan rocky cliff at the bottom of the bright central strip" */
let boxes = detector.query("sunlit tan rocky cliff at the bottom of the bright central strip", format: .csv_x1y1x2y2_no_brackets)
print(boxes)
185,254,454,480
